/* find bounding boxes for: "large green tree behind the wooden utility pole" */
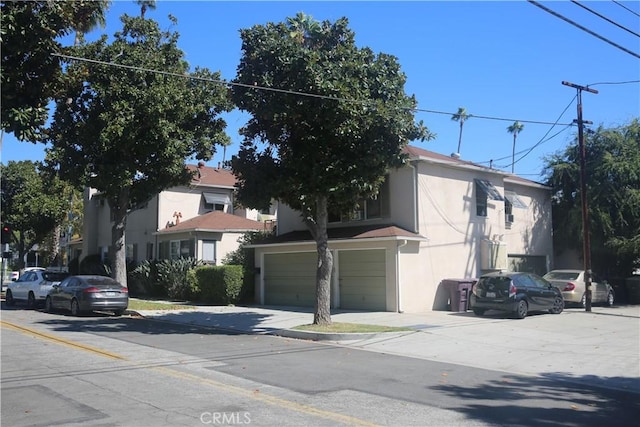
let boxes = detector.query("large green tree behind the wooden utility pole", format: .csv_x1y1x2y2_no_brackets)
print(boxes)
545,119,640,277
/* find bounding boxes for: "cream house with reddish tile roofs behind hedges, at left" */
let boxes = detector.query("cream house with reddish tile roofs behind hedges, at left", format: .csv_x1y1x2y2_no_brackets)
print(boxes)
76,163,275,265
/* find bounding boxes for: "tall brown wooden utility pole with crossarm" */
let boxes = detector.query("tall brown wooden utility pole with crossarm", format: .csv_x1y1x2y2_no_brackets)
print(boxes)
562,81,598,311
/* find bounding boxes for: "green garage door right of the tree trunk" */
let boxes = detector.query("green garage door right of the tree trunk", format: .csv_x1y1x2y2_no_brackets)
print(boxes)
339,249,387,311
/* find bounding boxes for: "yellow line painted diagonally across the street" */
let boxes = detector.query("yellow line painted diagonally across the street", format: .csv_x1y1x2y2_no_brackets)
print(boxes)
0,320,378,427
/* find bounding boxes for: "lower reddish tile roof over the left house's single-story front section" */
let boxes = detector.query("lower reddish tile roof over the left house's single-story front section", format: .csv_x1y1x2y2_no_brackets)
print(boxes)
158,211,269,234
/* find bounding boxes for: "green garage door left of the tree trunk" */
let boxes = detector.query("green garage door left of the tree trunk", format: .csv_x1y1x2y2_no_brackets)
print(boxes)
264,252,318,307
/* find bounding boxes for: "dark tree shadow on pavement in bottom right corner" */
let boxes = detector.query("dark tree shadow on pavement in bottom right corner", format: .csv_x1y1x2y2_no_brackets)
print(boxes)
431,372,640,427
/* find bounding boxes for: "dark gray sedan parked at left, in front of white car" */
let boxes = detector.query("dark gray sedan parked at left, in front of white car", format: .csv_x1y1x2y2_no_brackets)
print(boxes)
44,275,129,316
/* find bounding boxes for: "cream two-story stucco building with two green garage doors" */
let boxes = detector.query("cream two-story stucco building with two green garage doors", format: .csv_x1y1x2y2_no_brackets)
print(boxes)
248,146,553,312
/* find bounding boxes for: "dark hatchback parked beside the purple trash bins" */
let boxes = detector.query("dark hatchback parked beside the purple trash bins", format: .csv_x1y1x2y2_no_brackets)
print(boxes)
469,272,564,319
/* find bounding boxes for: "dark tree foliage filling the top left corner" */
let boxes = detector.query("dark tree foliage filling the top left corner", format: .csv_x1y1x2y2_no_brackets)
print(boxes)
0,0,109,142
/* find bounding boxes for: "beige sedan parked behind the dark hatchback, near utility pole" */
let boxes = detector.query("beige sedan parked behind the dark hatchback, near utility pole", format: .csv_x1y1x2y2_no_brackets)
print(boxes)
544,270,615,307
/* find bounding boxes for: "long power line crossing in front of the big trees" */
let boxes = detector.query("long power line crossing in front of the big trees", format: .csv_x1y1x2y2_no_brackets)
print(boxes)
52,53,571,126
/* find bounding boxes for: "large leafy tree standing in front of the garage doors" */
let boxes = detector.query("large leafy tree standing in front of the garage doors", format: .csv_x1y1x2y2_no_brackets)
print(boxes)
232,14,431,324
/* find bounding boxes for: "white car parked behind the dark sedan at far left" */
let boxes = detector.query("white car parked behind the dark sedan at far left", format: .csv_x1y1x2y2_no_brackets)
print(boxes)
5,269,69,308
